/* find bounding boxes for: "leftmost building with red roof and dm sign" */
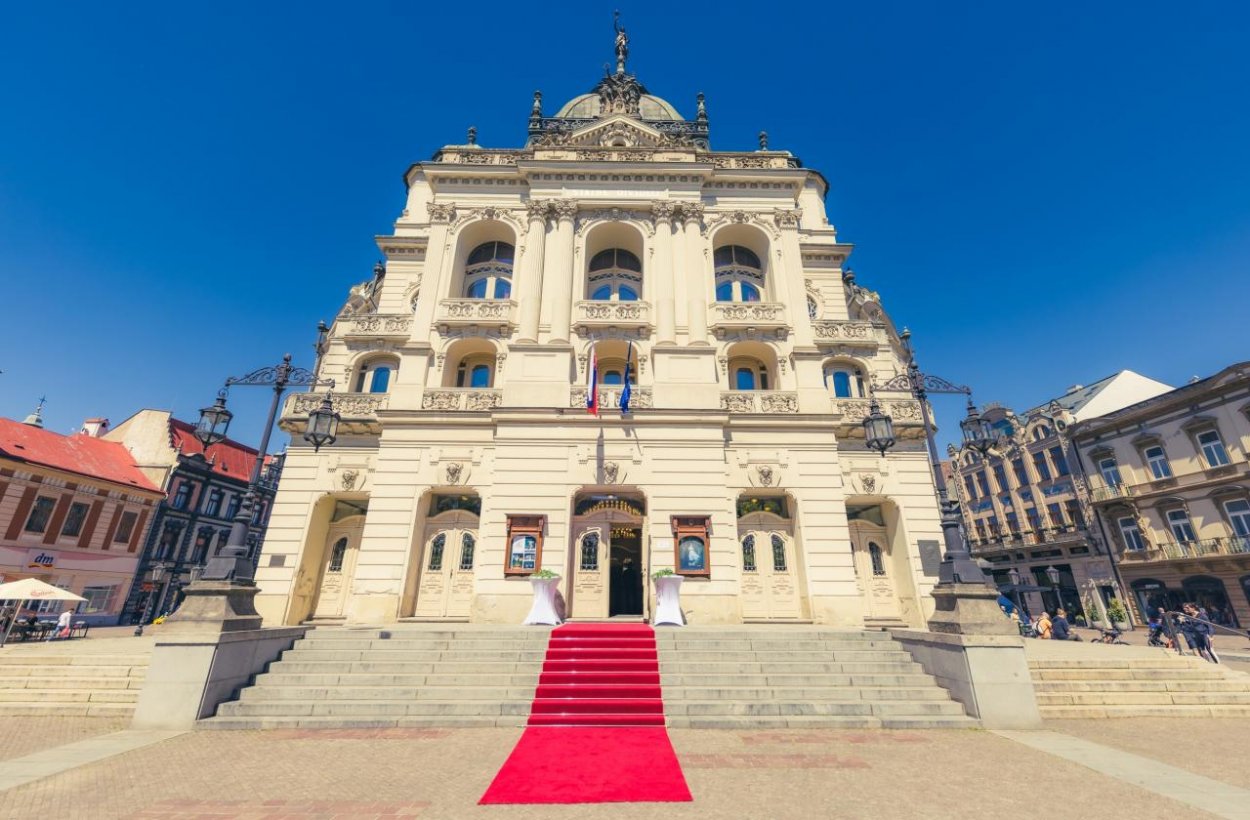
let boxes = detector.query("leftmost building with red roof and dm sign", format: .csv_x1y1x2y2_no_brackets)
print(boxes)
0,411,163,625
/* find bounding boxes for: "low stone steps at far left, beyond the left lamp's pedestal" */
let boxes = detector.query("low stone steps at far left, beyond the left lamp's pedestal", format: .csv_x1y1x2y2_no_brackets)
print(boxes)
0,645,149,718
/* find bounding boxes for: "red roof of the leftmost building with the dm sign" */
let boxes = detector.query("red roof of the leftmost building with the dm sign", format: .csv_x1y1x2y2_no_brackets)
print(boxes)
0,419,160,493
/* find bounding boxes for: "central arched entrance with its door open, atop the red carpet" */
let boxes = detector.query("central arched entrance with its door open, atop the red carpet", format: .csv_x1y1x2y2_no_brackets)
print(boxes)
570,493,649,619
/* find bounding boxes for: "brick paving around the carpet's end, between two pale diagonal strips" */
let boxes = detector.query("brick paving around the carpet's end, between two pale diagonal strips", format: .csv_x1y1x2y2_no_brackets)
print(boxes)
0,719,1231,820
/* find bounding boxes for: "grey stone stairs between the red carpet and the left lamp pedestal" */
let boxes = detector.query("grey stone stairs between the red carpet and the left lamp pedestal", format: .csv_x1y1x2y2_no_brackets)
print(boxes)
199,624,550,729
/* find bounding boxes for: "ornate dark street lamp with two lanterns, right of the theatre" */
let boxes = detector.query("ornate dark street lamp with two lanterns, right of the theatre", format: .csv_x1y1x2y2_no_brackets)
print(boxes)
864,329,1015,635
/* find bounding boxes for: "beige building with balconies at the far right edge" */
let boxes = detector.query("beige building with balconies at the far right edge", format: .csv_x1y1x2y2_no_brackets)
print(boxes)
1071,361,1250,628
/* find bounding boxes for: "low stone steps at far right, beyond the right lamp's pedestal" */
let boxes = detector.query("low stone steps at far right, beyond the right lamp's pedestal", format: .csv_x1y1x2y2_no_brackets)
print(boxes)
1028,641,1250,719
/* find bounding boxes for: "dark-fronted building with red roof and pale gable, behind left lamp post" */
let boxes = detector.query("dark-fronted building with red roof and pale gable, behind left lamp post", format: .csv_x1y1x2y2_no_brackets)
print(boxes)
102,410,283,623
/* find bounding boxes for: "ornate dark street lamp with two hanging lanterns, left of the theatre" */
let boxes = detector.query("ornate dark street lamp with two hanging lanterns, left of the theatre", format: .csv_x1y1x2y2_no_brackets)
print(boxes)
195,354,339,584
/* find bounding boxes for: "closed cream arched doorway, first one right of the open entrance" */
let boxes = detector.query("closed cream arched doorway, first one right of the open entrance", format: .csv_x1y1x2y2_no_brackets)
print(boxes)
738,496,803,621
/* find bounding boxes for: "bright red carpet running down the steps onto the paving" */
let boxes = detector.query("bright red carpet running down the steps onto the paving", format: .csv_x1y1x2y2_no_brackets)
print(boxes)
479,624,691,804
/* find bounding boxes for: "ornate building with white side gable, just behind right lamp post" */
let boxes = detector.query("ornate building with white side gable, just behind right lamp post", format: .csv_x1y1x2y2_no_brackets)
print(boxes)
949,370,1171,624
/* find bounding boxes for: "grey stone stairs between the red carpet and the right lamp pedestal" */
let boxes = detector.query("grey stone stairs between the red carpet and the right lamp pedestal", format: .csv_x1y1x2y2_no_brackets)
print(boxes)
656,626,978,729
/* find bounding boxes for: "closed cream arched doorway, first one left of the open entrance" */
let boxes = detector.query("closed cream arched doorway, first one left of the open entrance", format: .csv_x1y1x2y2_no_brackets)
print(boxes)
413,505,478,620
